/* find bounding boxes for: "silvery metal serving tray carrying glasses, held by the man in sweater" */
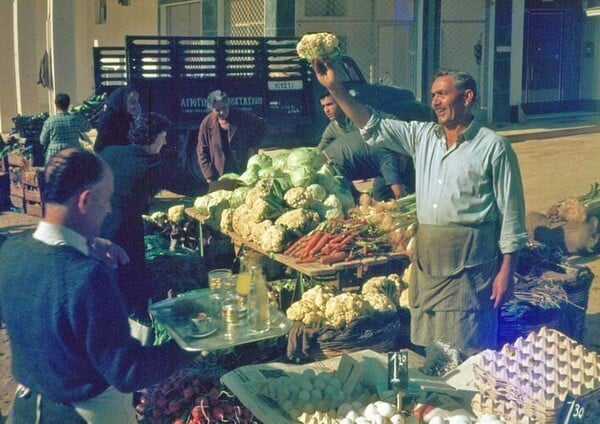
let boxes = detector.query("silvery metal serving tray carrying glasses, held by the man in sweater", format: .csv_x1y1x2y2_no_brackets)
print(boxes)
149,289,292,351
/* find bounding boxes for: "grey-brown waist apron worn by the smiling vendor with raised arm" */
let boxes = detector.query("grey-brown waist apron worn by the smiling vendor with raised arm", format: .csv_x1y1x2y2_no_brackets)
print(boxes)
409,223,499,346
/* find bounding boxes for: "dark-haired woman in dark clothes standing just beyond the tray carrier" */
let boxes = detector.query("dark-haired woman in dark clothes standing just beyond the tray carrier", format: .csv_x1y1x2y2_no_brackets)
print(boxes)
100,113,170,317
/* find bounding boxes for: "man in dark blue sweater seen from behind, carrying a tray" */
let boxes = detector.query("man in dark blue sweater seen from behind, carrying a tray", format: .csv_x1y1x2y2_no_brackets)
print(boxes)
0,149,194,424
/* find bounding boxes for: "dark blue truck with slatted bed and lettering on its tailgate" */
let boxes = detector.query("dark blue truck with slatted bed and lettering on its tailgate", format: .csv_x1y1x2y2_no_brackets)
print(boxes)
94,36,433,194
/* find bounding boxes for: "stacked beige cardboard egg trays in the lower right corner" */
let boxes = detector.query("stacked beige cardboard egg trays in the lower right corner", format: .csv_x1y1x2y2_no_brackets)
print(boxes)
471,327,600,424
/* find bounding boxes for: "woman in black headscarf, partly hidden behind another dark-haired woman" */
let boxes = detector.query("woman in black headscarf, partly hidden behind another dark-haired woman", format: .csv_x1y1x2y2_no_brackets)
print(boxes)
94,86,142,152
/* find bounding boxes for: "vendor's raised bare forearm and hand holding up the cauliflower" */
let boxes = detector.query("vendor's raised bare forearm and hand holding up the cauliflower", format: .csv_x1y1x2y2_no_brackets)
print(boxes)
312,60,371,128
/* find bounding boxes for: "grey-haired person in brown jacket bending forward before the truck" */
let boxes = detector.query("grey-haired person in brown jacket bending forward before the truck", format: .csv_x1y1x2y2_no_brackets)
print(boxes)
197,90,267,184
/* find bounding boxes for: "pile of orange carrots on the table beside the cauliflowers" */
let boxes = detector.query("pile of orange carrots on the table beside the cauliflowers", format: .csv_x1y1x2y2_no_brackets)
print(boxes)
284,219,390,264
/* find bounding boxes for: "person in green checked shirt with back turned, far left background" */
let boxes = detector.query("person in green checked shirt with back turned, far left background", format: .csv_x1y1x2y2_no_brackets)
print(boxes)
40,93,92,163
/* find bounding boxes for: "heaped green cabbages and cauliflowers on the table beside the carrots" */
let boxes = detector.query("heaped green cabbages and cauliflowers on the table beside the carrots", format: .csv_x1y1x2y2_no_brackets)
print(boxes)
194,147,355,253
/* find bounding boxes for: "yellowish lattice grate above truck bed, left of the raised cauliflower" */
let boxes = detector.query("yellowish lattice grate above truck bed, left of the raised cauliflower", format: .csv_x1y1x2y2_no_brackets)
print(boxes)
224,0,265,37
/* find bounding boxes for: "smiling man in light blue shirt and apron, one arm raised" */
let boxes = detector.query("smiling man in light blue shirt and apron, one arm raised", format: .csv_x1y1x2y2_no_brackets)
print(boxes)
312,61,527,353
